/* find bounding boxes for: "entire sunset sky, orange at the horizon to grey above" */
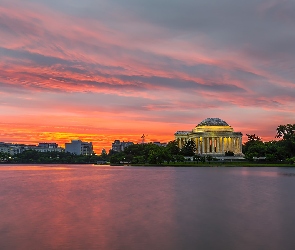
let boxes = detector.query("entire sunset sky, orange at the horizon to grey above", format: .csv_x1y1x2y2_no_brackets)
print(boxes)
0,0,295,153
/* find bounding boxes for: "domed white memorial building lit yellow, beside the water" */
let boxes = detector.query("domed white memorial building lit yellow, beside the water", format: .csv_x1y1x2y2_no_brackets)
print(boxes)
174,118,243,156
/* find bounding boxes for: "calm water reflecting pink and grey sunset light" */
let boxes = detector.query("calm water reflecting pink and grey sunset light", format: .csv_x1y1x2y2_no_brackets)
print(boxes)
0,165,295,250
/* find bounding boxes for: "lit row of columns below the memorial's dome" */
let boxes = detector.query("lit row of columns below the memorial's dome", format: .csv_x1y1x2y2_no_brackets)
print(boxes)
178,136,242,154
